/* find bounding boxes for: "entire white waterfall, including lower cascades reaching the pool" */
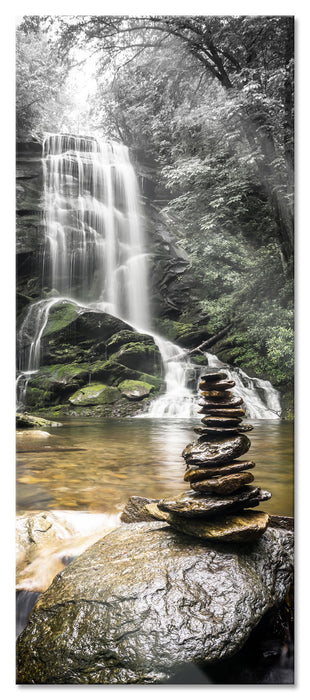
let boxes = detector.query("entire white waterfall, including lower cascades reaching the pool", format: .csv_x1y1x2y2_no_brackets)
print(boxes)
17,134,280,418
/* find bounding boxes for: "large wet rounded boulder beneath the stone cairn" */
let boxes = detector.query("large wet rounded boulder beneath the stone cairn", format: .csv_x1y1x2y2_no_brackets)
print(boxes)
17,522,293,684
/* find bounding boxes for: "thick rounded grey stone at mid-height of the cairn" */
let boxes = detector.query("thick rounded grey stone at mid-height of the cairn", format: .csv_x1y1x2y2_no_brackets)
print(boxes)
182,435,251,466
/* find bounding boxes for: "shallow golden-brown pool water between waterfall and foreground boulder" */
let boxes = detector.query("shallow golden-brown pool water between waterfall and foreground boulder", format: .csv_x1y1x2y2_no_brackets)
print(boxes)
16,417,294,516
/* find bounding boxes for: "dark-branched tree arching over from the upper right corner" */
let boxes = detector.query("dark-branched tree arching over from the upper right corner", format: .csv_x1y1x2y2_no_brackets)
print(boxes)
44,15,294,275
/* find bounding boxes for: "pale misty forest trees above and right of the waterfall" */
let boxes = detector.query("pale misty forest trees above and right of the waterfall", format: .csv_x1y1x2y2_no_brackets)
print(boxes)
16,10,294,417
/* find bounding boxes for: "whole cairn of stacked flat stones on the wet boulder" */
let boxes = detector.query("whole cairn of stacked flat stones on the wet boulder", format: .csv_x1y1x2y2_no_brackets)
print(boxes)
147,369,271,542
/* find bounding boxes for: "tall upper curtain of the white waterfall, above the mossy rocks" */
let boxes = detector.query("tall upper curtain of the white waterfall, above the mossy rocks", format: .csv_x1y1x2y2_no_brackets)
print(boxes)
43,134,149,330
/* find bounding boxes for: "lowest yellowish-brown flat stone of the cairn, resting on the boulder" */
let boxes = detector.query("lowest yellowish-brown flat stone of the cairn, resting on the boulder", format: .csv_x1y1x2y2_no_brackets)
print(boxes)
162,510,269,542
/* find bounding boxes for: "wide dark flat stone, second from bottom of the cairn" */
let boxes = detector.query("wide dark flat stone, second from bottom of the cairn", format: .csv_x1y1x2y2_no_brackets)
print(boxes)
157,486,271,518
